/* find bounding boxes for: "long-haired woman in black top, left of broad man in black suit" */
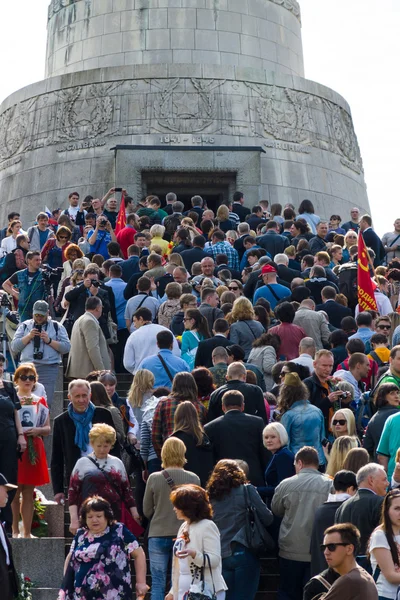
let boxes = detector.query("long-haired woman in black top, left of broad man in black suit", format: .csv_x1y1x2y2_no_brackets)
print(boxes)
171,400,214,487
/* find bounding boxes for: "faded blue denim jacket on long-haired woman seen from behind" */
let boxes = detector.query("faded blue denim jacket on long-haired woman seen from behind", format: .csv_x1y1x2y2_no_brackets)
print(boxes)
281,400,326,465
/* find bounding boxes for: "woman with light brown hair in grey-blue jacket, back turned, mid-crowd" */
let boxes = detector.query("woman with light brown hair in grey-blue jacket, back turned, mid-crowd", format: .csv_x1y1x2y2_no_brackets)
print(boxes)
229,296,264,360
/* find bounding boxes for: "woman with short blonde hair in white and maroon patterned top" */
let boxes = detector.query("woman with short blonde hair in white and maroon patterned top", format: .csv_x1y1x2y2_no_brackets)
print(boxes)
68,423,139,535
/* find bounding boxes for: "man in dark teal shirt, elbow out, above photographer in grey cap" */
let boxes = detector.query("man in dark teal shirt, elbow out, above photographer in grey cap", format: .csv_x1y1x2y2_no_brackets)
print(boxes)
3,250,47,321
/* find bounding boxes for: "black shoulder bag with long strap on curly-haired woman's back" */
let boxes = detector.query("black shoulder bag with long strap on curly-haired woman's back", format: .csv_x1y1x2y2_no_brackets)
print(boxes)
232,485,275,554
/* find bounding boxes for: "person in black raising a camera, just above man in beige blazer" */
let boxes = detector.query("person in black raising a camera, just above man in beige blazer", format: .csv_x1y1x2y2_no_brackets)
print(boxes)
65,265,117,340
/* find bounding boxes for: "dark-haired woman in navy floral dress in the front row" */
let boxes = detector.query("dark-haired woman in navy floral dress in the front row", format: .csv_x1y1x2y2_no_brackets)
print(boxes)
58,496,149,600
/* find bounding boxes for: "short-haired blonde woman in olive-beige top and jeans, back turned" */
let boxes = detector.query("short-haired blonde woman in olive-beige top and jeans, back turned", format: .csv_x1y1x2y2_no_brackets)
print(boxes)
143,437,200,600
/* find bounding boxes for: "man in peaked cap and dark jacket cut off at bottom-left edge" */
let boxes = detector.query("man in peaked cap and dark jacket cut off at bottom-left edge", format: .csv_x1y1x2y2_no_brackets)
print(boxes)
0,473,19,600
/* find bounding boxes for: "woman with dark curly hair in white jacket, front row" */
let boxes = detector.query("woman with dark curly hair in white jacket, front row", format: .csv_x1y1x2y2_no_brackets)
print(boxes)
165,484,227,600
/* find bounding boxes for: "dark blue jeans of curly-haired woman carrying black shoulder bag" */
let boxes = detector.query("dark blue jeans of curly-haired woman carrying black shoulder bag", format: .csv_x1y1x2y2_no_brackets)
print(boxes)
222,544,260,600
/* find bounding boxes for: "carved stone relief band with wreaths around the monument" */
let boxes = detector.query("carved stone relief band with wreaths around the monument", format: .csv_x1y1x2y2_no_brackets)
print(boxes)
0,77,362,173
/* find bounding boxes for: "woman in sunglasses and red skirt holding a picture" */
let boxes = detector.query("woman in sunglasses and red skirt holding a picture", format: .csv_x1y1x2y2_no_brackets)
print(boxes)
11,363,50,538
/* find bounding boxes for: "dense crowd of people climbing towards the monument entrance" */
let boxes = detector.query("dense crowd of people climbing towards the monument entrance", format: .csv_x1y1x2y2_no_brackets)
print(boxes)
0,188,400,600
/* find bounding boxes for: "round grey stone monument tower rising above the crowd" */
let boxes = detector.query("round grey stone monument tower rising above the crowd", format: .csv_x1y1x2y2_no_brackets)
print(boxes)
0,0,368,222
